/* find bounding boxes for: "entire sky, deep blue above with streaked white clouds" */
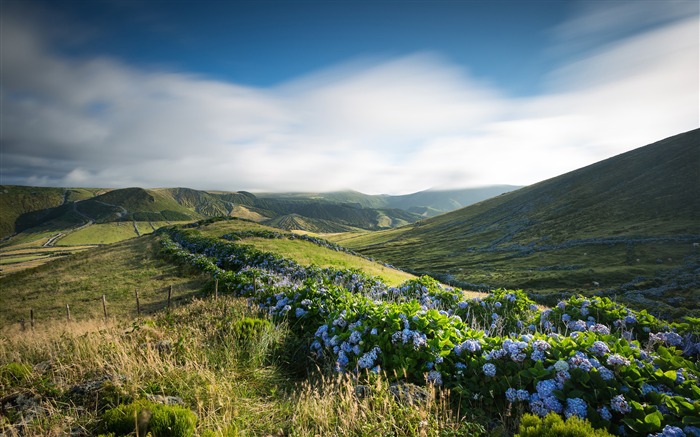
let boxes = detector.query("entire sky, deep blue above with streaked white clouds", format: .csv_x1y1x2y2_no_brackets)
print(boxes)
0,0,700,194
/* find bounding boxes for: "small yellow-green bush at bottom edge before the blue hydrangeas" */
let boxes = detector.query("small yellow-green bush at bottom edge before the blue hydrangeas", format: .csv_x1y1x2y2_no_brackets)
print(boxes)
516,413,612,437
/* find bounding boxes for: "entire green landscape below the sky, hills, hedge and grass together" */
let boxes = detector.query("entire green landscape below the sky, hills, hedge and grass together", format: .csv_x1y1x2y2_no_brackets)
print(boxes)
0,130,700,436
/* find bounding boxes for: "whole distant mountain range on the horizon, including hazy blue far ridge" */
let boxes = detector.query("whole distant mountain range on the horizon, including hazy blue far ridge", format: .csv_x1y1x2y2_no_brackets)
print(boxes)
0,186,512,237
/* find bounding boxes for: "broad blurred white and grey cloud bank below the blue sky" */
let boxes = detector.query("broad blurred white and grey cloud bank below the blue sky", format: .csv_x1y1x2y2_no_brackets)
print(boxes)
0,3,700,194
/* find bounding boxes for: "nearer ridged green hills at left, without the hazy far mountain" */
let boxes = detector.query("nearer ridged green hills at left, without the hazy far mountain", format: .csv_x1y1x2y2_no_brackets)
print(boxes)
0,182,421,237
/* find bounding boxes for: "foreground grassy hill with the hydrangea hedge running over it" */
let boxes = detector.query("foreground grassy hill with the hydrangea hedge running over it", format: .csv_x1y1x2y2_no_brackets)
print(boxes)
0,220,700,437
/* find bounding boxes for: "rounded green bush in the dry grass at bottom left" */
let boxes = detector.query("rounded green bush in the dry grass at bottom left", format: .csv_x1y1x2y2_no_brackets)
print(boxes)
102,400,197,437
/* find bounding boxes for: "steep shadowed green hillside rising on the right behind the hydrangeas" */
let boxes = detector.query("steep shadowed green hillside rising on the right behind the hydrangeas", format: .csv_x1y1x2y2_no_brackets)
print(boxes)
334,130,700,311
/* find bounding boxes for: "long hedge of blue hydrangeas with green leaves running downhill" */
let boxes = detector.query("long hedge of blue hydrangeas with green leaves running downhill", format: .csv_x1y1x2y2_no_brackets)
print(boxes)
154,225,700,435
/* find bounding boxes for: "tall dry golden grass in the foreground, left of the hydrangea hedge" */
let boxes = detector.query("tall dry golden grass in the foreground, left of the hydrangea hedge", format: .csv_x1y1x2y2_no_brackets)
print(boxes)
0,297,480,436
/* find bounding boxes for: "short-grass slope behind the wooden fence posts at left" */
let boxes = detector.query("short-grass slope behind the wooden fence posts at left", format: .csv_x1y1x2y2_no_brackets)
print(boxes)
0,236,207,326
